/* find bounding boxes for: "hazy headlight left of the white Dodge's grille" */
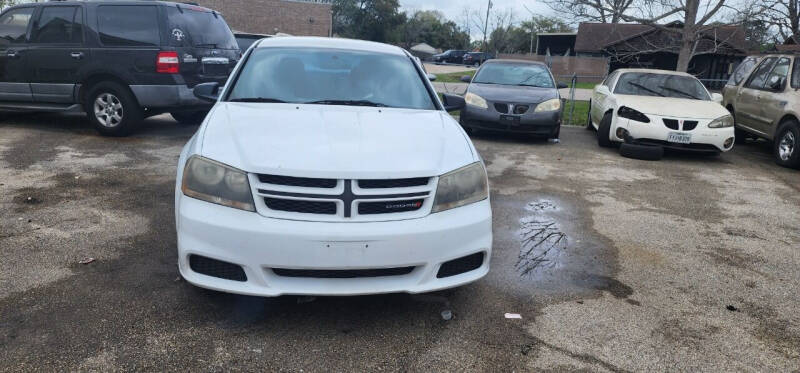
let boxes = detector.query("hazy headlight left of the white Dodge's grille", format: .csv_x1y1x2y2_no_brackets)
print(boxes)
181,156,256,211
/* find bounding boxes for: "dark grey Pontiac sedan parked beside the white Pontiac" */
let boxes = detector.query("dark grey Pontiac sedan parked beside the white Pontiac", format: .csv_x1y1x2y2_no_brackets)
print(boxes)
459,60,566,139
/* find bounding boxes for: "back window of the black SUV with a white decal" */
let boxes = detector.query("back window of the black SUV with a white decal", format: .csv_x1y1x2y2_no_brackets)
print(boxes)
167,6,234,49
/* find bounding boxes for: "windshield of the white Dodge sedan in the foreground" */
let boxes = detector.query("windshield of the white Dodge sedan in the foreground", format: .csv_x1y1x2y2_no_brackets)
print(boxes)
228,48,436,110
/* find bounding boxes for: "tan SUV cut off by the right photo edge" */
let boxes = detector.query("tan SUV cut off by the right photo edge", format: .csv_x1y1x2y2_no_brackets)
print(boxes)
722,54,800,168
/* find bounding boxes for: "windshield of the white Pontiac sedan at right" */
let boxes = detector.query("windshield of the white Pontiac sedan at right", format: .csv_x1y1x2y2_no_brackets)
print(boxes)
614,73,711,100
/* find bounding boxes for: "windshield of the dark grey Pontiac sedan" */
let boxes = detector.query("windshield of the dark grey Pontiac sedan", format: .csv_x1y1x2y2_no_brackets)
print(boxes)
472,63,555,88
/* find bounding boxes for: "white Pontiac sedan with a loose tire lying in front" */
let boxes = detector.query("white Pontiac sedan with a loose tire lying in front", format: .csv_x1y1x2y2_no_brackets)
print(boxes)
588,69,734,159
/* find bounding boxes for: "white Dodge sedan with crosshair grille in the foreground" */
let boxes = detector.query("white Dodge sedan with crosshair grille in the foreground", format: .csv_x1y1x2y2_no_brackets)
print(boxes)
175,37,492,296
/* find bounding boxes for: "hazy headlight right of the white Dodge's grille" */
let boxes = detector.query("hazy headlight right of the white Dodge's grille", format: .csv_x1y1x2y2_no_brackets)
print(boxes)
433,162,489,212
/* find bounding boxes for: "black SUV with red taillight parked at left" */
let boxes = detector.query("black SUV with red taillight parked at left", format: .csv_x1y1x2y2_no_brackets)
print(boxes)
0,1,241,136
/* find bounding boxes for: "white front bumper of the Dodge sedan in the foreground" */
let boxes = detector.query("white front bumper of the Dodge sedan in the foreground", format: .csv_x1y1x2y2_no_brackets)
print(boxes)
176,196,492,296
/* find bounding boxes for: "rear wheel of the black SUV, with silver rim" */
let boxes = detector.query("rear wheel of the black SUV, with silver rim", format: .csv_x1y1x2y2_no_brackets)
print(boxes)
84,82,142,136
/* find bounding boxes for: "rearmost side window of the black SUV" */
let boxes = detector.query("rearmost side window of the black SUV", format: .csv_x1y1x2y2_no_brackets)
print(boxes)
97,5,161,47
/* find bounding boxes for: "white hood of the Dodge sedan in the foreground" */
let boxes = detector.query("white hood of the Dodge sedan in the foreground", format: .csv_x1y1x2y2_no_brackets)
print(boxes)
200,102,478,179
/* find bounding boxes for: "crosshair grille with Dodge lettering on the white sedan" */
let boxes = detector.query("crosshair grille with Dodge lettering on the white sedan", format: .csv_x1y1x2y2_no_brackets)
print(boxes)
254,175,436,221
